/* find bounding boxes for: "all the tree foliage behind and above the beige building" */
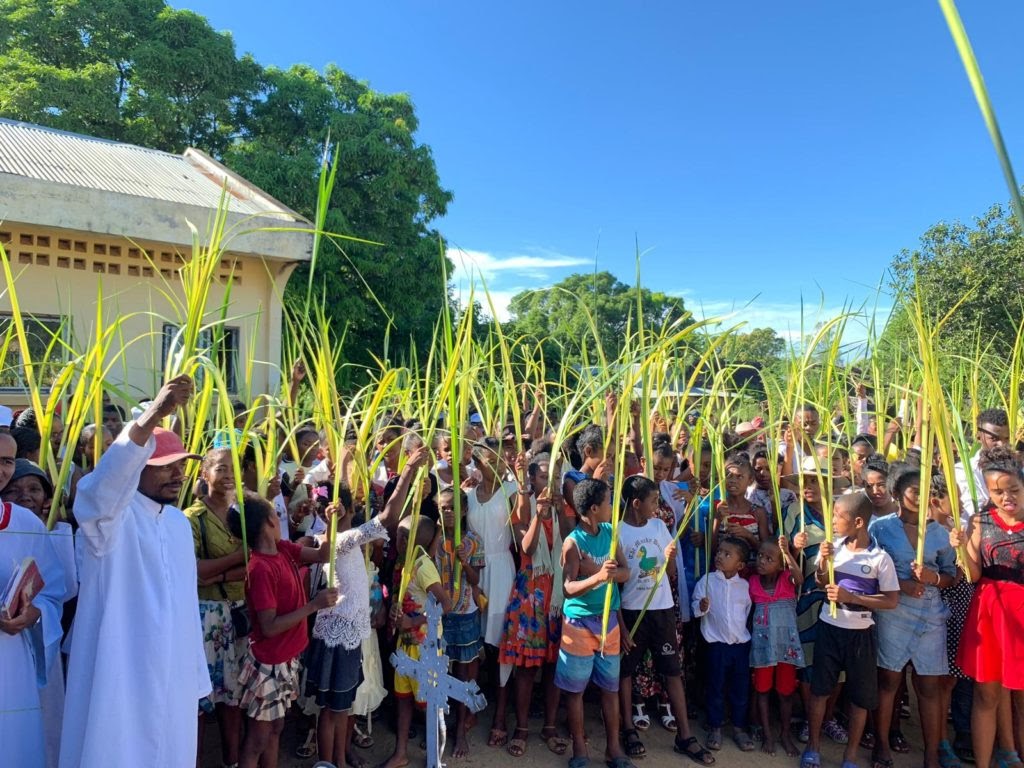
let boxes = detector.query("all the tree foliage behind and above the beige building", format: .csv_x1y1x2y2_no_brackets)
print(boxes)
0,0,452,372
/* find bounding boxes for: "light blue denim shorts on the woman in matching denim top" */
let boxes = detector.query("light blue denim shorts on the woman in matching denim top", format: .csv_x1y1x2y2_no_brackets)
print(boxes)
874,590,949,676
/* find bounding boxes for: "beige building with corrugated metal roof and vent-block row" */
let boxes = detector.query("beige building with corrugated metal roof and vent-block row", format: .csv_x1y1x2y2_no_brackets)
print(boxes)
0,119,313,407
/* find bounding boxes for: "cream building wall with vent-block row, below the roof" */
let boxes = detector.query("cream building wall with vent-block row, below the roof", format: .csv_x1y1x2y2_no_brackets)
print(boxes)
0,221,296,407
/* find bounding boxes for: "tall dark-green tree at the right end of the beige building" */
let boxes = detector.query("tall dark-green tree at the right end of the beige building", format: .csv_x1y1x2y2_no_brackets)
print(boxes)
225,66,452,370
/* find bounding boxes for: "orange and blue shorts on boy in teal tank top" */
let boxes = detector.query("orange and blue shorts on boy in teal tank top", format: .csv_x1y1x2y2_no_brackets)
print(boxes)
555,613,620,693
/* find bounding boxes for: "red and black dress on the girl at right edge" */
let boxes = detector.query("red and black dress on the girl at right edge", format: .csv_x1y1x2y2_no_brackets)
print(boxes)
956,508,1024,690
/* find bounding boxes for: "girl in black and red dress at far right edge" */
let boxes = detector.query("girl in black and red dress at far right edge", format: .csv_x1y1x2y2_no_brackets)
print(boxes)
949,447,1024,766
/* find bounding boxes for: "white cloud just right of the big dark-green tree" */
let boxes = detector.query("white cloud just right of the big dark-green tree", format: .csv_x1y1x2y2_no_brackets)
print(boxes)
447,248,591,322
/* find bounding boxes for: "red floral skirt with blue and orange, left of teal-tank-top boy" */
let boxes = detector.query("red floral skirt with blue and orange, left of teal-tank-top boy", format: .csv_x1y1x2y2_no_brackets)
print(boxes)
498,563,561,667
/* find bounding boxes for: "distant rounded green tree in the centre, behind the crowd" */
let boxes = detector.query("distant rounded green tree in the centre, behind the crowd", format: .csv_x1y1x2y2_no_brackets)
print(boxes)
508,271,686,373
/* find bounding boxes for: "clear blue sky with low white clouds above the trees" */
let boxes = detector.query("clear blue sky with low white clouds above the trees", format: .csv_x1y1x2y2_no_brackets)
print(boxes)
186,0,1024,334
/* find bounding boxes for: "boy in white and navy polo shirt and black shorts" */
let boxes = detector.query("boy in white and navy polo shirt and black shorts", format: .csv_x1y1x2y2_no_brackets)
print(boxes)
800,493,899,768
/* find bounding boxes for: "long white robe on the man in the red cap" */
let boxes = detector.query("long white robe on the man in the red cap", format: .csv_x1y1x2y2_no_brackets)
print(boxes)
60,425,211,768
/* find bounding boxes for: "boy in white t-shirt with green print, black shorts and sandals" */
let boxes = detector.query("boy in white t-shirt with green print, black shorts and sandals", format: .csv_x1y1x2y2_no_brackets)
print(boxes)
618,475,715,765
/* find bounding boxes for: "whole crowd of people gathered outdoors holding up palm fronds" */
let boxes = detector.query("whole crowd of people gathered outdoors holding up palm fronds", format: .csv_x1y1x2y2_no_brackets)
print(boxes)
0,377,1024,768
